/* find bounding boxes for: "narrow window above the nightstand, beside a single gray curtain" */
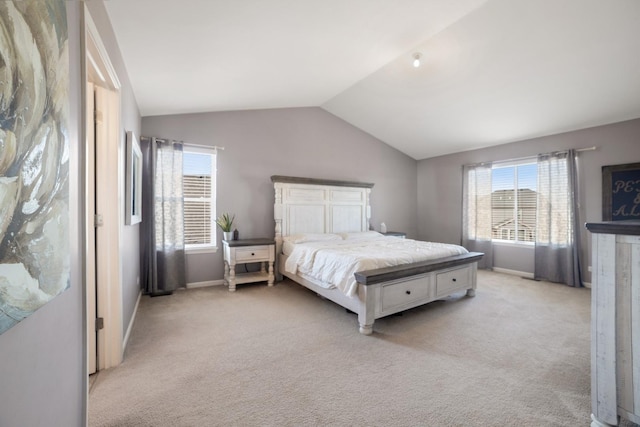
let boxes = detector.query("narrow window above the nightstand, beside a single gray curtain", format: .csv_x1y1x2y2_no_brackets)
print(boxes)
182,149,216,251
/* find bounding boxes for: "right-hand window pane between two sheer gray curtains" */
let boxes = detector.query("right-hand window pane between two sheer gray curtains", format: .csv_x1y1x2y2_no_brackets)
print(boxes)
491,160,538,243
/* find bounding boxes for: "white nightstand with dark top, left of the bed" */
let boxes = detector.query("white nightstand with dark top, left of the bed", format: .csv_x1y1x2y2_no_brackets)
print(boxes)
222,239,276,292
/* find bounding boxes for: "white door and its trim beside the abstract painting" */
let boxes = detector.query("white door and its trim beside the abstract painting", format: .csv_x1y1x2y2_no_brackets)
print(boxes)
84,6,124,373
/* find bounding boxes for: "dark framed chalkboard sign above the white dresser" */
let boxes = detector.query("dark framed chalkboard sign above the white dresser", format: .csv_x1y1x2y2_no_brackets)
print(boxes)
602,163,640,221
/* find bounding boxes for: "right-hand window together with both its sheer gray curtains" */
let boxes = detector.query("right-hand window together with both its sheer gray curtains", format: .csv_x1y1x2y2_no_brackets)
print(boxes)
462,150,580,286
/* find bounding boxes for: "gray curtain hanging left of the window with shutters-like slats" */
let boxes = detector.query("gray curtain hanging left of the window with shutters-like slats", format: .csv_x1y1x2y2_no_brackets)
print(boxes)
140,137,186,296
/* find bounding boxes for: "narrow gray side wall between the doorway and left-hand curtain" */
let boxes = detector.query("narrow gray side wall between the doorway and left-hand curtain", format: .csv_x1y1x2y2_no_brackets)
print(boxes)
85,1,140,335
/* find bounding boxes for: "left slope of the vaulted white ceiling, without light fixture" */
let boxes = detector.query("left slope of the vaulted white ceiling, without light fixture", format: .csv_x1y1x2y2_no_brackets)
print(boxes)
105,0,485,116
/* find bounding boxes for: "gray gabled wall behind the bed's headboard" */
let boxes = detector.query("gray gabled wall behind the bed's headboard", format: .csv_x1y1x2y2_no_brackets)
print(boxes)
142,108,417,283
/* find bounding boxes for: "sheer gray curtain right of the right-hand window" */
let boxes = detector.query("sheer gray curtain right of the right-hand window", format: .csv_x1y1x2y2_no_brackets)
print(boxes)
534,150,582,287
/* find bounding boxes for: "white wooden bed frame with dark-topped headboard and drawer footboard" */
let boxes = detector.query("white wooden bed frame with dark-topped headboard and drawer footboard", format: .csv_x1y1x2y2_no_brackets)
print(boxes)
271,176,483,335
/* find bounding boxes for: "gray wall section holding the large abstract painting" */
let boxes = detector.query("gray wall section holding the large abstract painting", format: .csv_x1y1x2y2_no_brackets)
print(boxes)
0,2,87,427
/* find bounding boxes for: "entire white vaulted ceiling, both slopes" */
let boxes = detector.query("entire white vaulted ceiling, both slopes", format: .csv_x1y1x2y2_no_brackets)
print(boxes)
105,0,640,159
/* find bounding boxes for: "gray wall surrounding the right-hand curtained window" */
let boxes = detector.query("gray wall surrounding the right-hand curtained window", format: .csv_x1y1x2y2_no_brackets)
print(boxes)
418,119,640,281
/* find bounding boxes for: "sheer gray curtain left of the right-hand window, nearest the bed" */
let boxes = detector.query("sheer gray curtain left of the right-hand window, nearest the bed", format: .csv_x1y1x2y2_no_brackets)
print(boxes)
462,163,493,269
